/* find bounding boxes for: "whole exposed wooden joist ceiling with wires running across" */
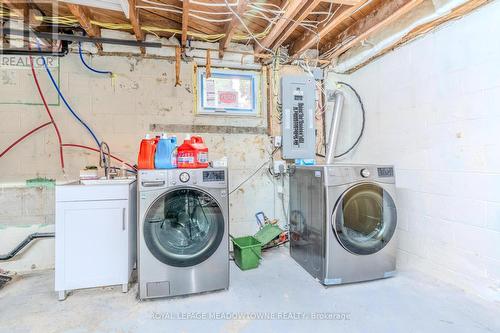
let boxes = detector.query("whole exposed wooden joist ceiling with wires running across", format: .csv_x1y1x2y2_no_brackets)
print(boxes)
1,0,484,73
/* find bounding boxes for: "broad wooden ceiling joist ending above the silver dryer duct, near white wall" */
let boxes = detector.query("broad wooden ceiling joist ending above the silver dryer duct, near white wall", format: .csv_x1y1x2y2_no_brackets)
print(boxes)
321,0,424,59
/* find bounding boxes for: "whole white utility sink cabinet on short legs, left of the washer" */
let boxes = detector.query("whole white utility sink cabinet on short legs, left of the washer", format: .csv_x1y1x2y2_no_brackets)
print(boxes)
55,179,137,300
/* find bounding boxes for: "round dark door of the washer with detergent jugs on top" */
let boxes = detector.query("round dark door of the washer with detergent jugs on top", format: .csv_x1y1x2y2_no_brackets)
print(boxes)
143,189,224,267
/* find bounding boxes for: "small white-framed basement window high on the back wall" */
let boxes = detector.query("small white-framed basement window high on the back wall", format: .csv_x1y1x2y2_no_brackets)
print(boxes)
197,68,260,116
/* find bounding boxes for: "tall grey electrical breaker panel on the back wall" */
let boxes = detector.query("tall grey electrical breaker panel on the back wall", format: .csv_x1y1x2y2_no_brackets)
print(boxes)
281,75,316,159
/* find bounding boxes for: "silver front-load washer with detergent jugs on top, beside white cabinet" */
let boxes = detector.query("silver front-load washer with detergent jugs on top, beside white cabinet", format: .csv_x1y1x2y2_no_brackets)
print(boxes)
137,168,229,299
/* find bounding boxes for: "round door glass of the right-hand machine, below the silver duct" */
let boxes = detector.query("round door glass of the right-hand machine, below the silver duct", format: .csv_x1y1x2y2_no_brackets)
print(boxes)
332,183,397,255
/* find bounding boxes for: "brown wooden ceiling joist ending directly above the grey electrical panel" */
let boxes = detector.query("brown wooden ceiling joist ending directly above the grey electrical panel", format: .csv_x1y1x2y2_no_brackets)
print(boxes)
289,0,369,56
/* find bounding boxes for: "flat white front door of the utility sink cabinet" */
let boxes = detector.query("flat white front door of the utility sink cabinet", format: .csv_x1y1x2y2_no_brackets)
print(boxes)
56,200,128,290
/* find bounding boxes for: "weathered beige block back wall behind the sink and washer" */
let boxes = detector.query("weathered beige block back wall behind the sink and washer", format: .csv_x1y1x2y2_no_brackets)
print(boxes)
0,54,282,270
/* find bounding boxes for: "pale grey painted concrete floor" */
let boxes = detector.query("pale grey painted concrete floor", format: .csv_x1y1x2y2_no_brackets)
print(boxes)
0,248,500,333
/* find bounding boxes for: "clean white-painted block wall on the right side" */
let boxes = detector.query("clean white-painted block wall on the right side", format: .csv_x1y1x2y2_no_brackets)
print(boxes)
329,1,500,301
